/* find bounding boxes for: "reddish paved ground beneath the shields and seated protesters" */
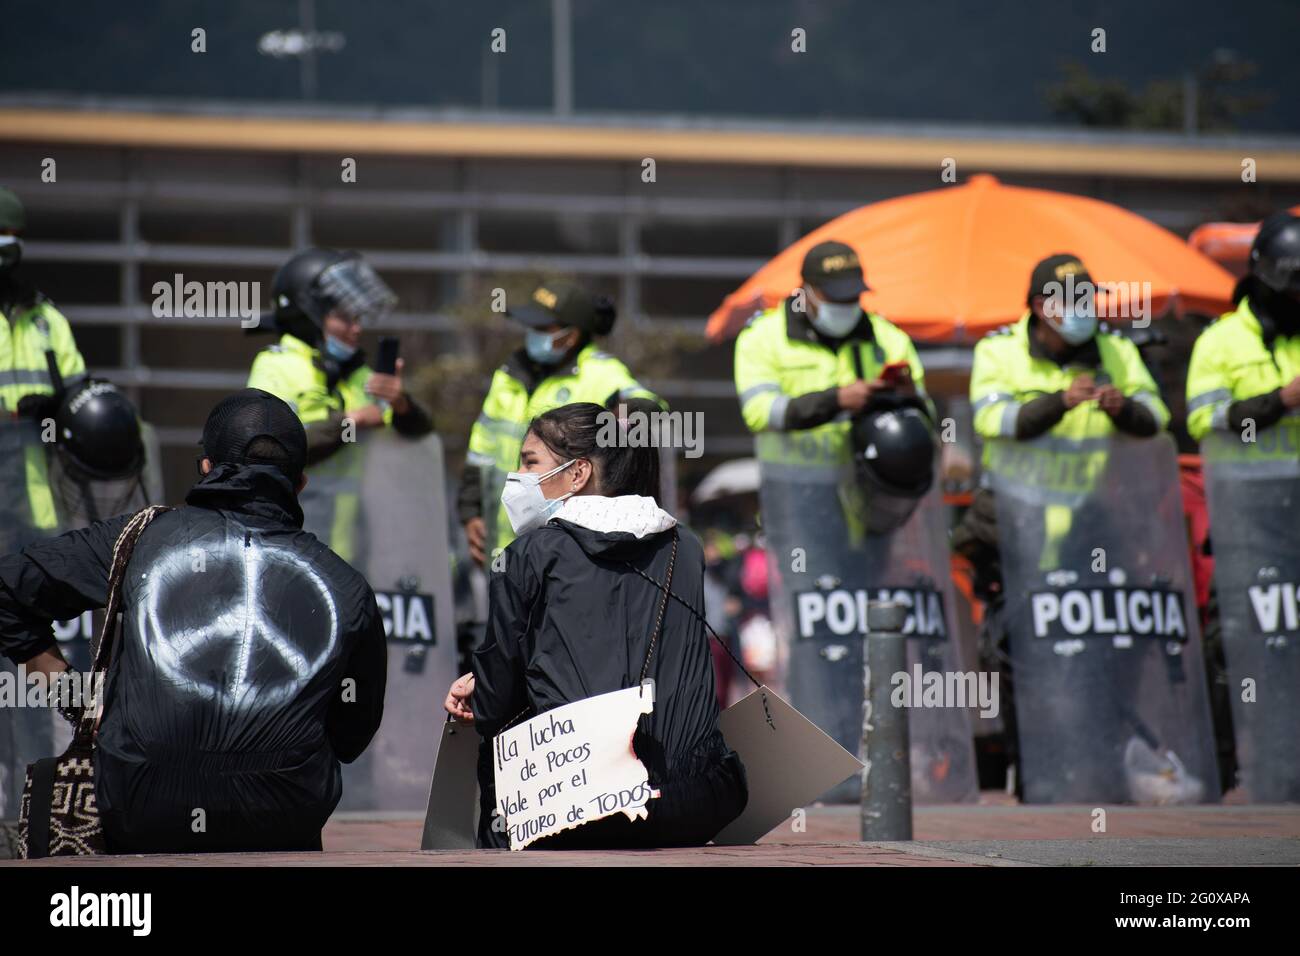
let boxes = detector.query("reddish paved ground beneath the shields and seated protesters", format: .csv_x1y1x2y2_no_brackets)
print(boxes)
0,795,1300,866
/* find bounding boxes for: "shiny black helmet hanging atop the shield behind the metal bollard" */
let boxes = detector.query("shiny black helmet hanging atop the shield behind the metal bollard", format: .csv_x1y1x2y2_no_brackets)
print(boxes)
852,399,935,535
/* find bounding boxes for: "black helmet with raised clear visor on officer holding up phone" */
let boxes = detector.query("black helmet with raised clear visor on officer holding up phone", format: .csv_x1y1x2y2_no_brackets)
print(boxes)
270,248,397,346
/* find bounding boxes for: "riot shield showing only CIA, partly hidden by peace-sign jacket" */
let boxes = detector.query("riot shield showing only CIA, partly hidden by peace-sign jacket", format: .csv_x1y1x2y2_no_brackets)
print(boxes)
300,429,456,810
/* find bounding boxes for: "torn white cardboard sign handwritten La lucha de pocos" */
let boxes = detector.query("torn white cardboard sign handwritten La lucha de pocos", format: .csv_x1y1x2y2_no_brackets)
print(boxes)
493,682,659,849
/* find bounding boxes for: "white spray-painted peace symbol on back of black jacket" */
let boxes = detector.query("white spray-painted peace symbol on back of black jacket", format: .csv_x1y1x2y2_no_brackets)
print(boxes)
135,536,339,710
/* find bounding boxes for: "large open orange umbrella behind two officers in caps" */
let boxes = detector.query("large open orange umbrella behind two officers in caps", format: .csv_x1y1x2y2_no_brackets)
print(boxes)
707,174,1232,342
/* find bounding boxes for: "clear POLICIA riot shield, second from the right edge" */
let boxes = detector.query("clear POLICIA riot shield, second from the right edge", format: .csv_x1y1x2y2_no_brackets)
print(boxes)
985,434,1219,804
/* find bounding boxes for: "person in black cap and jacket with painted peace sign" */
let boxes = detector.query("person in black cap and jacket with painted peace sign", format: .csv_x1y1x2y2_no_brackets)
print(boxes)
0,389,387,853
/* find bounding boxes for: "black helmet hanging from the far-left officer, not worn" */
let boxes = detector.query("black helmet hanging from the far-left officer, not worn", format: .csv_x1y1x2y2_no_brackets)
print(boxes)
55,378,144,480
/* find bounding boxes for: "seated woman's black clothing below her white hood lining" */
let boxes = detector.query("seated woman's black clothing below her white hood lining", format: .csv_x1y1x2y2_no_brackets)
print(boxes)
471,518,749,849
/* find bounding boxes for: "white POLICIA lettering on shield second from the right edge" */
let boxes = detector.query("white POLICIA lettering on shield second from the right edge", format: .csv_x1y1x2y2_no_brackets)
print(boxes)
1030,588,1187,641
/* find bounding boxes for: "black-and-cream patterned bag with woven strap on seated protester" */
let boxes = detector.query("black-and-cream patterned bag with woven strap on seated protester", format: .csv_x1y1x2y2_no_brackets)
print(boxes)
18,505,169,860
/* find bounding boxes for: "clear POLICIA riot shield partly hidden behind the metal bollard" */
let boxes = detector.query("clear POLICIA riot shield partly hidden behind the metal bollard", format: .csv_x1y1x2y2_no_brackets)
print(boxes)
757,432,979,803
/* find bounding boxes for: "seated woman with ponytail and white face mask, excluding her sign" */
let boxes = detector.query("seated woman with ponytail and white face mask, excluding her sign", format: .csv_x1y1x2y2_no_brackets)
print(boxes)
446,403,749,849
